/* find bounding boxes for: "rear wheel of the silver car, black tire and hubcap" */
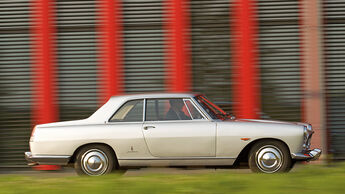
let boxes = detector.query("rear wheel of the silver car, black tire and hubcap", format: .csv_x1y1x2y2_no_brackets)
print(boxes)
74,145,118,176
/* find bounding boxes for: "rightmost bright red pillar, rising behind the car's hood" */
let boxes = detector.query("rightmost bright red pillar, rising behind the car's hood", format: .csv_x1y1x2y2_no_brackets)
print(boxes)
231,0,260,118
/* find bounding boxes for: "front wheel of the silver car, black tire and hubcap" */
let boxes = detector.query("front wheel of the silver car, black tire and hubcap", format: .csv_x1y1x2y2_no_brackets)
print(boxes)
248,140,293,173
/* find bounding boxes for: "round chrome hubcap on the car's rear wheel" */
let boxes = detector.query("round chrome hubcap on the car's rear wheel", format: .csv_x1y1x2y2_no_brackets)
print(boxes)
81,149,108,176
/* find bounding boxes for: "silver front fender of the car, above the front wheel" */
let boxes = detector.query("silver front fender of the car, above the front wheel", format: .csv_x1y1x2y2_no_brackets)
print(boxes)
216,121,303,158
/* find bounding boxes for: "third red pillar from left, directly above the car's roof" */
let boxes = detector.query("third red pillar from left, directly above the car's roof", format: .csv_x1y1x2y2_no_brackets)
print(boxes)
164,0,191,92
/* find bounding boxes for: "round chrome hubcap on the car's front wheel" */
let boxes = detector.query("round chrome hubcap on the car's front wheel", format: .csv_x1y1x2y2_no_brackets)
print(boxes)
255,145,283,173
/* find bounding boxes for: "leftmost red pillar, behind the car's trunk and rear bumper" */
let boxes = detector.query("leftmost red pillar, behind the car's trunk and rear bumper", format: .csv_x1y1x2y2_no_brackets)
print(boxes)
31,0,58,170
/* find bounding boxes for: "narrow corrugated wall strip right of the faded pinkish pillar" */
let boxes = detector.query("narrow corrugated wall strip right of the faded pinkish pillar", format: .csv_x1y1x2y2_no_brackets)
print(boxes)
323,0,345,159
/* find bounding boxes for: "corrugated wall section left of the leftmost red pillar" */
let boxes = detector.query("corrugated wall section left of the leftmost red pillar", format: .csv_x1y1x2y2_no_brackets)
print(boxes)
0,0,32,167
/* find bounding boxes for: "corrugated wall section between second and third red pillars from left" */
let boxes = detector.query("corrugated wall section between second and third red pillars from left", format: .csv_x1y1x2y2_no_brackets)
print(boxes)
122,0,165,93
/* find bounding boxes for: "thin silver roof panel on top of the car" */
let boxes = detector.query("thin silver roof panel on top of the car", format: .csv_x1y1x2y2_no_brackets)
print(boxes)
111,92,199,99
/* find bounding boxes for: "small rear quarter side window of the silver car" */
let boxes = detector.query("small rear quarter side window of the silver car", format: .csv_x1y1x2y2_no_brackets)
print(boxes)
110,100,144,122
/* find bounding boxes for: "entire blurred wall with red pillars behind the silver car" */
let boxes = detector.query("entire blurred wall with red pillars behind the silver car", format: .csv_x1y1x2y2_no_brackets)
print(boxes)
0,0,345,167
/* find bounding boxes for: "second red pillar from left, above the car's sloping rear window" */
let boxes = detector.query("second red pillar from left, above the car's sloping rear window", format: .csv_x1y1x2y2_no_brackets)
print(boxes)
97,0,123,103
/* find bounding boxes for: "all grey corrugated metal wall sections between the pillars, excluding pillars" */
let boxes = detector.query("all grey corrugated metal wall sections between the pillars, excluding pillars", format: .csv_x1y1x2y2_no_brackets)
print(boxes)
0,0,345,166
